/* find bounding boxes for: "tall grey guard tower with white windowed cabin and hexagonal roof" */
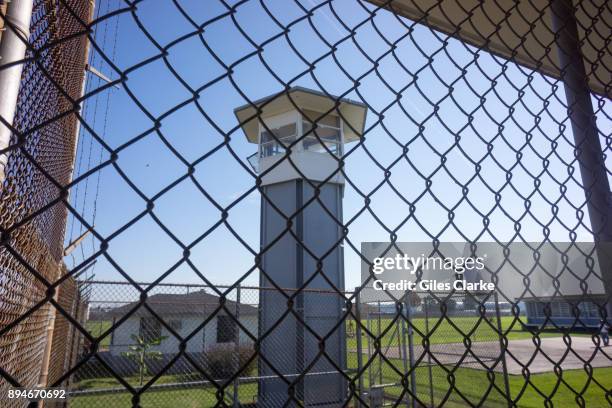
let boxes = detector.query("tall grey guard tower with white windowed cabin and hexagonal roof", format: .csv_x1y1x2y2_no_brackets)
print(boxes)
235,87,366,407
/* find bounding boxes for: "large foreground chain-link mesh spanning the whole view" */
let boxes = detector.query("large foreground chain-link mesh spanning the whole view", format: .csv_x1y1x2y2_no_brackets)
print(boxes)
0,0,612,407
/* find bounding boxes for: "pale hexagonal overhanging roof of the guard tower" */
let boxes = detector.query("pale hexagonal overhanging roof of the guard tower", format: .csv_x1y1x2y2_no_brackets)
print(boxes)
234,86,367,143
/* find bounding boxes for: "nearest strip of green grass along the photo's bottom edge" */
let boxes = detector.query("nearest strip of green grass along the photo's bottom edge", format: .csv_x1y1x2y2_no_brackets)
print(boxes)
70,367,612,408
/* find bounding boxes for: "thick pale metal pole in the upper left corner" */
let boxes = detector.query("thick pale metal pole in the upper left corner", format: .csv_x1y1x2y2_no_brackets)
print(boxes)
0,0,33,186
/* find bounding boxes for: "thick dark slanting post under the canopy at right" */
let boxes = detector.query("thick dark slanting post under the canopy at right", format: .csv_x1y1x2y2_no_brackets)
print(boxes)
551,0,612,318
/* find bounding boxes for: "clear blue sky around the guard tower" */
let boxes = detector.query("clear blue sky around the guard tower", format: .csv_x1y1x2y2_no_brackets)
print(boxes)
66,0,612,288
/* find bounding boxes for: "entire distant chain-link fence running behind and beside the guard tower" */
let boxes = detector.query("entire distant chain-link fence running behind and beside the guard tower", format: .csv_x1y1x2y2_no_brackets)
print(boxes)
64,281,507,408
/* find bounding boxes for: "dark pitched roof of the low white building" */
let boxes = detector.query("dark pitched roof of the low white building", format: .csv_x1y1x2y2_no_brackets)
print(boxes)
108,289,257,319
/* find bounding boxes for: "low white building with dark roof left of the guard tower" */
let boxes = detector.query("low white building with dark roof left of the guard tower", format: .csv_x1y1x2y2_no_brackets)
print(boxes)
109,290,257,355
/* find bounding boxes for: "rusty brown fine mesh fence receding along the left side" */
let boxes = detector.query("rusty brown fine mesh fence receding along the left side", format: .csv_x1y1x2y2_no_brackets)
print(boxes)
0,0,90,405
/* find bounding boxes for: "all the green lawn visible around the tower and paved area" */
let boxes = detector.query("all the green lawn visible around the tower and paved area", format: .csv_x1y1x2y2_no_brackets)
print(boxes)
70,317,612,408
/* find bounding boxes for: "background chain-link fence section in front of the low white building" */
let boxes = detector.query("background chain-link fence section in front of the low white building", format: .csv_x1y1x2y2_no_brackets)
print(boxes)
70,281,359,407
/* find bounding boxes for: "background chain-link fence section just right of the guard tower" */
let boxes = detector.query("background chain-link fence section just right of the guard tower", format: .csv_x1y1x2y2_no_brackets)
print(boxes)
356,291,511,406
